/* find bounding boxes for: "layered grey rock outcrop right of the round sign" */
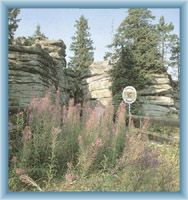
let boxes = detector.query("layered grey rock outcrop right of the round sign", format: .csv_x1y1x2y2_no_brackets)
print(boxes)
138,74,178,117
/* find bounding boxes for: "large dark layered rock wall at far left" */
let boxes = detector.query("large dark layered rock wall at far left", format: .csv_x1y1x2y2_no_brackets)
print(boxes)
8,39,66,108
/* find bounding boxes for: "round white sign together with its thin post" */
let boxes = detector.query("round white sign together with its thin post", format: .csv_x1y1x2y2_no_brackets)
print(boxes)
122,86,137,130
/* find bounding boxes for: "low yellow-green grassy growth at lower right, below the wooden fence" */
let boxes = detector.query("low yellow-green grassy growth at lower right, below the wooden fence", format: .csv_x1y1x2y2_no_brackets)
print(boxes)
47,138,180,192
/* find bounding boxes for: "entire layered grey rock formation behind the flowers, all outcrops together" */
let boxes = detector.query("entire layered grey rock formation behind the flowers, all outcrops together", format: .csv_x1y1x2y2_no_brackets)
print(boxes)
8,38,179,116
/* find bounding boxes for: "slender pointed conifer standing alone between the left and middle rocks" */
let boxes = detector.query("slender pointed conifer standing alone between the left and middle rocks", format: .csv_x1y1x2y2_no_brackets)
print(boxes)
69,16,94,71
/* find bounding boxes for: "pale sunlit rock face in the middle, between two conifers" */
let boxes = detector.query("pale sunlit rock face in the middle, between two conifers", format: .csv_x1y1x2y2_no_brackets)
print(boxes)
86,61,112,106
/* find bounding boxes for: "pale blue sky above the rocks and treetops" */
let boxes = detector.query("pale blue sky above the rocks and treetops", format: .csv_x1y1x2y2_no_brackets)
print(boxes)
16,8,180,61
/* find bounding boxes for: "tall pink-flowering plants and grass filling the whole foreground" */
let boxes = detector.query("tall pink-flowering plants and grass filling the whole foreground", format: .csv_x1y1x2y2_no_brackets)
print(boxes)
9,91,179,191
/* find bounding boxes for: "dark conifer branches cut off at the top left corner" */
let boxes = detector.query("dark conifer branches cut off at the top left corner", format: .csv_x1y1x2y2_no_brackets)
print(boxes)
8,8,21,44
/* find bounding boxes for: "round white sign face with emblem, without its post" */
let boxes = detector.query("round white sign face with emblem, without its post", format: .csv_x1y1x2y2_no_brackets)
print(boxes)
122,86,137,104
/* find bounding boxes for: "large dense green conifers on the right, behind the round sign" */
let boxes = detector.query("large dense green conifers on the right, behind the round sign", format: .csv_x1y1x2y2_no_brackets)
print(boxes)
105,8,179,114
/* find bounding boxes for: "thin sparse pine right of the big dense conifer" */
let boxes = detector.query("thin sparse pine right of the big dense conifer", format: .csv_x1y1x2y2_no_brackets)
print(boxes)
157,16,174,64
